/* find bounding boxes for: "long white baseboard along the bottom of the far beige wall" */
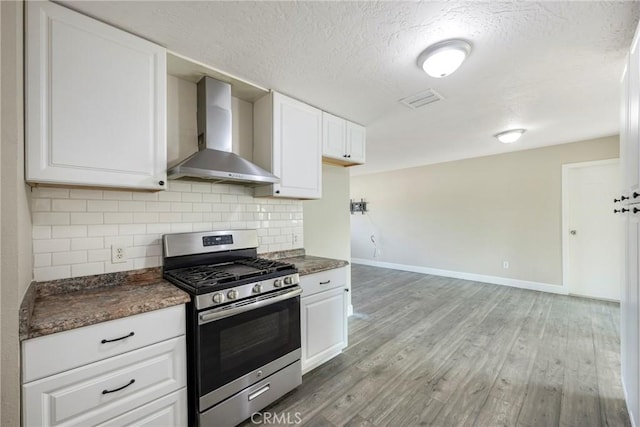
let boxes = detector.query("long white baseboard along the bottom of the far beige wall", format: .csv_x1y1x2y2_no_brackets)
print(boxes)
351,258,569,295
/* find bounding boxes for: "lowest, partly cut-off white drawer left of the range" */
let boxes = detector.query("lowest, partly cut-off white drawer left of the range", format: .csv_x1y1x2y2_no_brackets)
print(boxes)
98,388,187,427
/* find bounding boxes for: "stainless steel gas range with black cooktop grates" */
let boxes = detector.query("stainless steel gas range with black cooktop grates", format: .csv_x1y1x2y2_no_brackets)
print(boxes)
162,230,302,427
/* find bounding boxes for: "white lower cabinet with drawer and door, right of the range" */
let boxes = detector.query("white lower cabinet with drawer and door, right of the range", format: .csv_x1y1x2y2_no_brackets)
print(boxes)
300,268,348,374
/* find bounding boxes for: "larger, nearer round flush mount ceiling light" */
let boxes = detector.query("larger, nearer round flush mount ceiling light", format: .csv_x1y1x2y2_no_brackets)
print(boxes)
418,39,471,78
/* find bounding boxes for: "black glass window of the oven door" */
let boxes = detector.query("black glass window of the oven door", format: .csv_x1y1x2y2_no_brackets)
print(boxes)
198,297,300,396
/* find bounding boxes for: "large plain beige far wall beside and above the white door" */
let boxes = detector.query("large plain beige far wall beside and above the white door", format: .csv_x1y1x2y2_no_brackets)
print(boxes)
351,136,619,286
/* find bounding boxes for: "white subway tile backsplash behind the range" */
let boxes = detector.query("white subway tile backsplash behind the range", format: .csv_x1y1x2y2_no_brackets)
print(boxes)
31,180,303,281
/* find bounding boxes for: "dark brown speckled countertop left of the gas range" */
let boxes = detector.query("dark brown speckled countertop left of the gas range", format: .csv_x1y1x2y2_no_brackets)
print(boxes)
20,268,191,341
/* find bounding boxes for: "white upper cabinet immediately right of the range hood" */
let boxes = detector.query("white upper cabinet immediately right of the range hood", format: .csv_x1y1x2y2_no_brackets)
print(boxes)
253,92,322,199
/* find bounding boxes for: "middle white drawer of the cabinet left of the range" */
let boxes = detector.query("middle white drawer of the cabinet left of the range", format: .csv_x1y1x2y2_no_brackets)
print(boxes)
23,336,186,426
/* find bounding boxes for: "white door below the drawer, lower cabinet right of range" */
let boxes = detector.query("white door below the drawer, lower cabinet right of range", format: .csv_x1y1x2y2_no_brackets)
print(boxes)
300,288,347,374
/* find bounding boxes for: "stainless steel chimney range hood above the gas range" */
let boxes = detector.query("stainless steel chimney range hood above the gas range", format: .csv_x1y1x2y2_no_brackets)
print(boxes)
167,76,280,185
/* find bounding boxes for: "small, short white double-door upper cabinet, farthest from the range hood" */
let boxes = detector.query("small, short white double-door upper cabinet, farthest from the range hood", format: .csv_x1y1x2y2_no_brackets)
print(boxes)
322,112,366,166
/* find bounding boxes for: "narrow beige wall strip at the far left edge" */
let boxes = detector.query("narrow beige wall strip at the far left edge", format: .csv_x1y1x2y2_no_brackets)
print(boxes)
0,1,32,427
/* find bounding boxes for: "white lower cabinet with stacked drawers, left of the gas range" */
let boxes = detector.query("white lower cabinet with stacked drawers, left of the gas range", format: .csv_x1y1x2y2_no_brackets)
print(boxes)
22,306,187,427
